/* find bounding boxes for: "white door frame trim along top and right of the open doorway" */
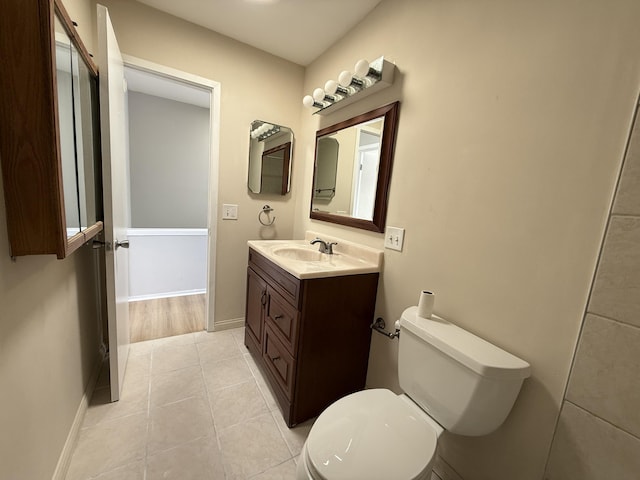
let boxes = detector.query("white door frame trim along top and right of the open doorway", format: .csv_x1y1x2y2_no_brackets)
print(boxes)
122,54,221,332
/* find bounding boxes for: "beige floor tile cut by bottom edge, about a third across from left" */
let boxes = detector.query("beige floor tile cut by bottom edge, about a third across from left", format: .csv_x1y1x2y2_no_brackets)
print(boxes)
146,437,224,480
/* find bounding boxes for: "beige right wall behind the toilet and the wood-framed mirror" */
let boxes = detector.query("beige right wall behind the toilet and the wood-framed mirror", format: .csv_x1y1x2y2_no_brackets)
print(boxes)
293,0,640,480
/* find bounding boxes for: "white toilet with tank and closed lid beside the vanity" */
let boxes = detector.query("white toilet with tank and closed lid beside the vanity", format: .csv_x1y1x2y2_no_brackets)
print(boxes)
296,307,529,480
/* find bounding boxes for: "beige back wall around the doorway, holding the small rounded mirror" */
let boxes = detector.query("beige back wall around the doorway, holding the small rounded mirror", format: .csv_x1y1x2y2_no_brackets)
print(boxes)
91,0,304,323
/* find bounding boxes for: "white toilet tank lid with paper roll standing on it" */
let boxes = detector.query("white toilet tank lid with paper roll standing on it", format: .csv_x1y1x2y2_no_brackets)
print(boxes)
400,307,531,378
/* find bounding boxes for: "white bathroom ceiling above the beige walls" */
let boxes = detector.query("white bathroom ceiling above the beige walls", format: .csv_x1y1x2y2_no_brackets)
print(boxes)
138,0,381,66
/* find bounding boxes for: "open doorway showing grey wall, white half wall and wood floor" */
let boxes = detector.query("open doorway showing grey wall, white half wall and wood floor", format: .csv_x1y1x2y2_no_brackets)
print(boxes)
124,57,220,343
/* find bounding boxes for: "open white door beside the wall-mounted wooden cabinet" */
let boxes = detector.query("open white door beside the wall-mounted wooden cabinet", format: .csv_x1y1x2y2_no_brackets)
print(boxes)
98,5,129,401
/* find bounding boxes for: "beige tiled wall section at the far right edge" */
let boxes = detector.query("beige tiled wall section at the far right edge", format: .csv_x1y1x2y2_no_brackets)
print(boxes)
545,106,640,480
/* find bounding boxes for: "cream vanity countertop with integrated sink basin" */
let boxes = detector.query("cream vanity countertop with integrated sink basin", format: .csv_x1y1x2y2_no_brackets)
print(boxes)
247,232,383,279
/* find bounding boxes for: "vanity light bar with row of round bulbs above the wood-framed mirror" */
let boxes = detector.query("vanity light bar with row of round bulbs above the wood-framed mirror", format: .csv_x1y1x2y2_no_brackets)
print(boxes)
302,57,395,115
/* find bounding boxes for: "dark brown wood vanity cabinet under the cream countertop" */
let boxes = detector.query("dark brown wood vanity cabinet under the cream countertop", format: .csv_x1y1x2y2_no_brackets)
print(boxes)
245,248,378,427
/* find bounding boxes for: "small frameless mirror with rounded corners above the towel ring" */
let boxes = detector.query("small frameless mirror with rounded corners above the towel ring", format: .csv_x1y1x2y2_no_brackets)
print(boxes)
247,120,293,195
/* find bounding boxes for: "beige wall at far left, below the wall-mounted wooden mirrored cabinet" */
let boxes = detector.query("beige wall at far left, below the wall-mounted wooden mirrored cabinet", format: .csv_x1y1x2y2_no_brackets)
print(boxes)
0,2,99,479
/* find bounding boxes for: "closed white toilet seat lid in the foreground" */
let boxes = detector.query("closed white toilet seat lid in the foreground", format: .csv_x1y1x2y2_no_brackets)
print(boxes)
304,389,442,480
